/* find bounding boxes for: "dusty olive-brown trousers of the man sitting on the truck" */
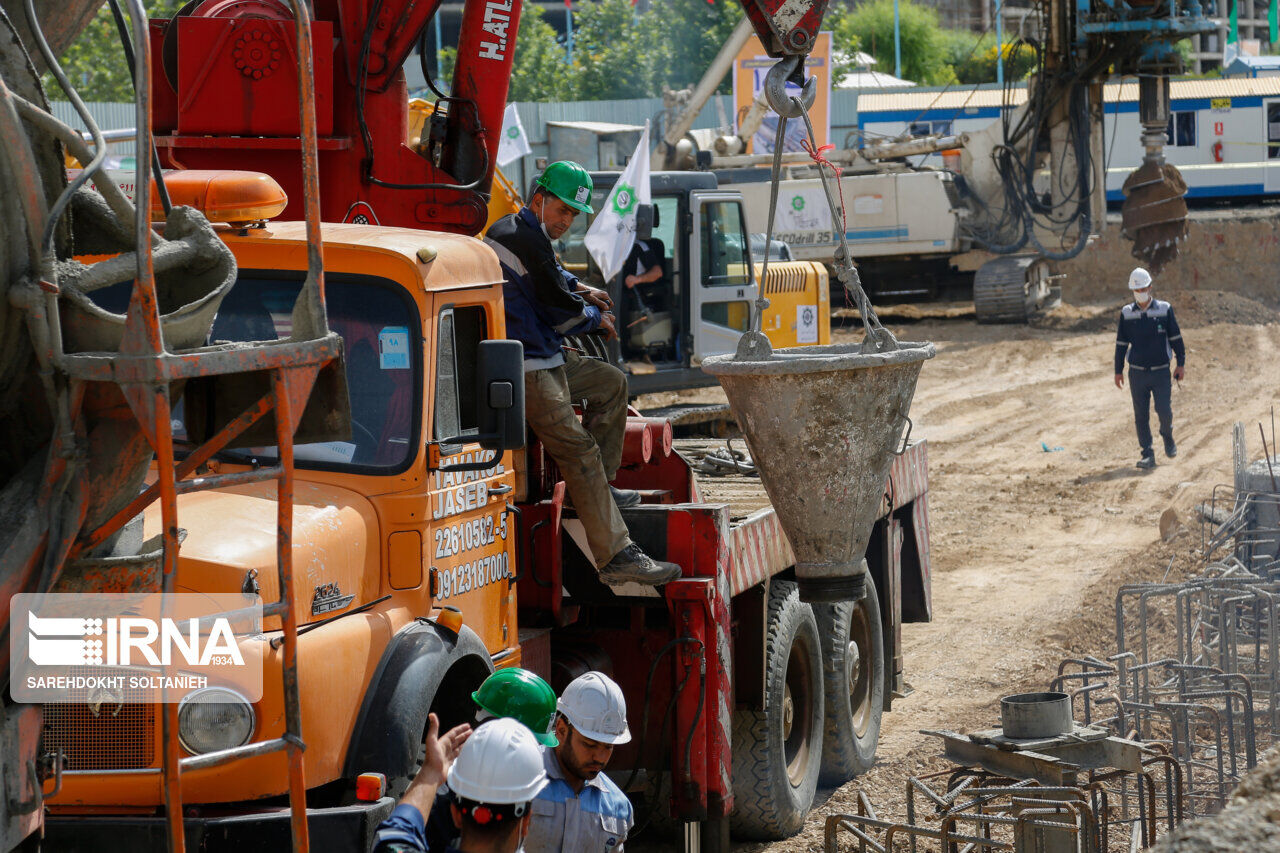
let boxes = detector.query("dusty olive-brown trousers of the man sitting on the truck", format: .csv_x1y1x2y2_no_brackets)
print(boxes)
525,352,631,567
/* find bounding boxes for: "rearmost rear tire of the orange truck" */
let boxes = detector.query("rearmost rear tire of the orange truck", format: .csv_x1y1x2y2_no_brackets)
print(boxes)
813,575,884,785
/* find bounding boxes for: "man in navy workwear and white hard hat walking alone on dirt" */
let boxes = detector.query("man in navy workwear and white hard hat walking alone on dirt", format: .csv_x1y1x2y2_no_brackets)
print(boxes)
1115,266,1187,469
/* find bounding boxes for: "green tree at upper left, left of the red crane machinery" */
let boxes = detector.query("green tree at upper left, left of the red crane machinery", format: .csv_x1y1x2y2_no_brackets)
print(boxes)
44,0,183,101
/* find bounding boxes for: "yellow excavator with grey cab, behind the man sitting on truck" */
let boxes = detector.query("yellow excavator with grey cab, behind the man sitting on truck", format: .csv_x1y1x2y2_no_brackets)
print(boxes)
408,99,831,391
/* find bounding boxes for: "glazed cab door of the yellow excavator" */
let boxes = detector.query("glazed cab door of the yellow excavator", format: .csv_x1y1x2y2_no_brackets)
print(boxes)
689,192,759,366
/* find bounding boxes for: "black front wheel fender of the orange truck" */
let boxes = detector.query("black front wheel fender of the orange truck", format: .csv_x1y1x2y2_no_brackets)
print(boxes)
343,619,493,779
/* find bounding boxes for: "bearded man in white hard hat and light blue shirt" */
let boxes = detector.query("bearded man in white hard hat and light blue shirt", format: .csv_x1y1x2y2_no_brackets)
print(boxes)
525,671,635,853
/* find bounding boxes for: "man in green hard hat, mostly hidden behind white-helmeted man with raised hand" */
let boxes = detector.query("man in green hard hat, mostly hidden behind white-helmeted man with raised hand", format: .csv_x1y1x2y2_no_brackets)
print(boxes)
426,666,559,850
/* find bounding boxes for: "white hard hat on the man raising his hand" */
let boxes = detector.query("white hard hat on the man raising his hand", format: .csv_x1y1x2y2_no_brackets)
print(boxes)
448,717,547,806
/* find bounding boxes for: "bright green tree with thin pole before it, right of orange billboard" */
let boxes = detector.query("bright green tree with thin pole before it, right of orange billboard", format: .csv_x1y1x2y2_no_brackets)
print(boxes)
833,0,955,86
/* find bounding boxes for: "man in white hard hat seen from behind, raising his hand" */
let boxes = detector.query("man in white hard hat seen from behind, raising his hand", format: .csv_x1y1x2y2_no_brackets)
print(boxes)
374,715,547,853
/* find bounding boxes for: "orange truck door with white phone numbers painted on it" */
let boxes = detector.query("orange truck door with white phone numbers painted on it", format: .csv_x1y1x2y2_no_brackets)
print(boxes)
425,295,517,653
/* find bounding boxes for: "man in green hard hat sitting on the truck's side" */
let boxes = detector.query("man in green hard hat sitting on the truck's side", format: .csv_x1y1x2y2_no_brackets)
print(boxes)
485,160,680,585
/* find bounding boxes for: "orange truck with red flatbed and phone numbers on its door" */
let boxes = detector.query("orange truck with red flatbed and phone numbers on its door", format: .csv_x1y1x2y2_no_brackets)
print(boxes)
35,194,929,853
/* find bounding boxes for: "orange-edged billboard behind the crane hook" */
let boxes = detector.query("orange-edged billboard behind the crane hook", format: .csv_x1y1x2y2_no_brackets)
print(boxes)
733,32,831,154
